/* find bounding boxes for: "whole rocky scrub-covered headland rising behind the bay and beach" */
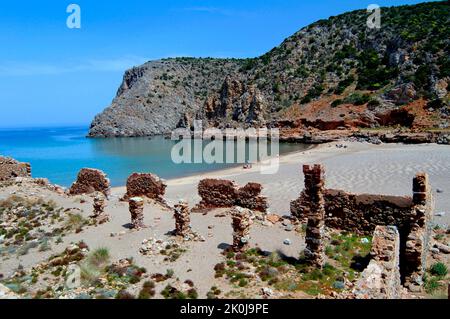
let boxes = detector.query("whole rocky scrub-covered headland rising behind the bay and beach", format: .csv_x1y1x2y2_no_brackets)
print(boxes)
90,2,450,136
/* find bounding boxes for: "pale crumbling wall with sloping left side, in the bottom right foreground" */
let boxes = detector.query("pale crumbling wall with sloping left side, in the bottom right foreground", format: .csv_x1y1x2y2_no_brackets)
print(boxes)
353,226,402,299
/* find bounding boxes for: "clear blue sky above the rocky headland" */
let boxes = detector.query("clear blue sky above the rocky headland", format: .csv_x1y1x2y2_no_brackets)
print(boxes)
0,0,436,127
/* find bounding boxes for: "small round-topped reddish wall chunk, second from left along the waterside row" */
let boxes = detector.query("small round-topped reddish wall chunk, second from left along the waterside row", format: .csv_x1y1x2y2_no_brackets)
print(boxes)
69,168,111,197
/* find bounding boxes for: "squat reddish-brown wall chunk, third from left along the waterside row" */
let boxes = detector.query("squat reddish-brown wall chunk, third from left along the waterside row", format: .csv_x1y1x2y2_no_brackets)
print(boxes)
122,173,167,204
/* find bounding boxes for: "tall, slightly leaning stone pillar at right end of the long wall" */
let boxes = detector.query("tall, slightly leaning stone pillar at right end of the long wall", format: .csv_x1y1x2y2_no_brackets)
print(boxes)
403,173,434,292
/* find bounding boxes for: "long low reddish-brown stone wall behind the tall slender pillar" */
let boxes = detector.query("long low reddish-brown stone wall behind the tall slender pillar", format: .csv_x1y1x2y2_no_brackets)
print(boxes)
291,189,413,235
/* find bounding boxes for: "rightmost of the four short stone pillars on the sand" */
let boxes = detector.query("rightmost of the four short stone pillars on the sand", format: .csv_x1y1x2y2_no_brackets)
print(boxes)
231,207,252,252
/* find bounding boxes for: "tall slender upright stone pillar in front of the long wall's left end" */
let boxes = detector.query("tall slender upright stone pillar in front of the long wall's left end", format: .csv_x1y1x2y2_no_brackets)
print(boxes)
303,165,325,268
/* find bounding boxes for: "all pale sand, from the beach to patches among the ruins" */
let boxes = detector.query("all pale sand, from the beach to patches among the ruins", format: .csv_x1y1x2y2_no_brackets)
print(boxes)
0,143,450,296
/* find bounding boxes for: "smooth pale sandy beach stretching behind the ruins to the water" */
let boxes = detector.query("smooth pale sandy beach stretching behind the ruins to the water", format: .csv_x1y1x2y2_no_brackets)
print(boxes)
129,143,450,224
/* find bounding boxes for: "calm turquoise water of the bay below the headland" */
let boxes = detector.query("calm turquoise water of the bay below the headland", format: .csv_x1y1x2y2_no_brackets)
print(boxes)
0,127,307,186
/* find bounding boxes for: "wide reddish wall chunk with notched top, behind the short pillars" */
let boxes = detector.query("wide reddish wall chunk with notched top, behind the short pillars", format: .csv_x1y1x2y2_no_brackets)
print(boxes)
194,179,268,213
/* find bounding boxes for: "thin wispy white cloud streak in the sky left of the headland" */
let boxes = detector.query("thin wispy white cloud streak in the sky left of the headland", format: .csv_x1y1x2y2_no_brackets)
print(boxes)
0,56,148,76
